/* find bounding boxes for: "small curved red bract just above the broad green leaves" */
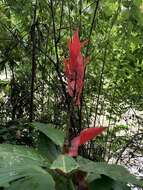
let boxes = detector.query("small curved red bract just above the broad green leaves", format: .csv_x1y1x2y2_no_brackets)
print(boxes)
68,127,106,156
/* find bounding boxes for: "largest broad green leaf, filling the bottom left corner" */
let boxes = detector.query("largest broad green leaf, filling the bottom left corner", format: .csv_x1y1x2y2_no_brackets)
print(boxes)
0,144,49,186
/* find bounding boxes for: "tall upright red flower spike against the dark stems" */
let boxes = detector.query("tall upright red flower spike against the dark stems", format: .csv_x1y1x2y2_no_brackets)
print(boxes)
64,31,84,106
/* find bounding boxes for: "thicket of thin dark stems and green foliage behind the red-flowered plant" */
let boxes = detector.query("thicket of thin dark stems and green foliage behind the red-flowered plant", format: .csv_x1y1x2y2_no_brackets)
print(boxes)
0,0,143,189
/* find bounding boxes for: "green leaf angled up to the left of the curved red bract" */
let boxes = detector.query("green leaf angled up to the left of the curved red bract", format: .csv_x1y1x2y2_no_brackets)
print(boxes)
33,122,64,147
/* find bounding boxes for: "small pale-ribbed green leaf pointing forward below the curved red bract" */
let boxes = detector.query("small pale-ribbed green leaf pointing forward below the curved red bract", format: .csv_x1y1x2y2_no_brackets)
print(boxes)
50,155,79,174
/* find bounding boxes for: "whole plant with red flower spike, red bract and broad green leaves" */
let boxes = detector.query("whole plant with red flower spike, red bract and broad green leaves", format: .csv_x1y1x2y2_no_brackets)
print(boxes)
0,32,143,190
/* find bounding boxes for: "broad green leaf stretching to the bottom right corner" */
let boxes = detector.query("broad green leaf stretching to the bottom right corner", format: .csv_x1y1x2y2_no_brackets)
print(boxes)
77,157,143,187
